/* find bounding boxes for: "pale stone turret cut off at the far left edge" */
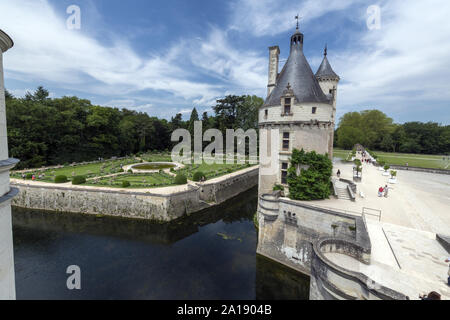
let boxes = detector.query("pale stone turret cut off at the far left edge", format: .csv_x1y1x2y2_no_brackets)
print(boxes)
0,30,18,300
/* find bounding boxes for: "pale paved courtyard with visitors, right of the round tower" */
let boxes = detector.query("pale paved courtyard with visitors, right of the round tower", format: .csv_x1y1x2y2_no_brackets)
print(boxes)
313,156,450,300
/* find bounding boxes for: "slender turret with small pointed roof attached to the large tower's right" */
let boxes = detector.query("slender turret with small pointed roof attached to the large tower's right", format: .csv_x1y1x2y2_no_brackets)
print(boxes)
316,46,340,157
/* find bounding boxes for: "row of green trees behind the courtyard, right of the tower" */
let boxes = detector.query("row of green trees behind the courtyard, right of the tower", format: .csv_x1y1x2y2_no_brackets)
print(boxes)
335,110,450,154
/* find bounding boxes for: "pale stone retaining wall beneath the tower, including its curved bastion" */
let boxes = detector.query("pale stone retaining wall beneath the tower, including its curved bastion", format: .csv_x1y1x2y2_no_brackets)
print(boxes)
257,192,406,300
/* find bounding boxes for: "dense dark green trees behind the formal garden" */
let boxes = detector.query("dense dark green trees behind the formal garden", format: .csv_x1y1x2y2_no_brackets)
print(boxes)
5,87,263,169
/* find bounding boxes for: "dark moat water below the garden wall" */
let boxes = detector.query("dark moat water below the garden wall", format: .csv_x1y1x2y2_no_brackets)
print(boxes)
13,188,309,300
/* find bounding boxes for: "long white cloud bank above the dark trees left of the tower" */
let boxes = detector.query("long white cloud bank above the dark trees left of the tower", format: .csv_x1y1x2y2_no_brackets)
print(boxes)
0,0,220,104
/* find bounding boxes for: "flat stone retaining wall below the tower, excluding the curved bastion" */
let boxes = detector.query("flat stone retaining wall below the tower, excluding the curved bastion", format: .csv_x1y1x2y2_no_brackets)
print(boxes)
257,195,362,275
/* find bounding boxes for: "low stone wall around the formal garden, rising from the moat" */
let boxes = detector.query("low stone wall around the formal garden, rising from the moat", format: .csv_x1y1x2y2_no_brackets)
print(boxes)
13,167,258,221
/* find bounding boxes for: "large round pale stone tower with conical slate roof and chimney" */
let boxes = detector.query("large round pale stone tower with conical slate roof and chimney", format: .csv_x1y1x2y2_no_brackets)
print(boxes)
258,26,335,195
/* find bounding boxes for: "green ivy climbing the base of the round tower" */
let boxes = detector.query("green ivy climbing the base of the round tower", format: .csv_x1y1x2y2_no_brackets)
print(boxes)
287,149,333,200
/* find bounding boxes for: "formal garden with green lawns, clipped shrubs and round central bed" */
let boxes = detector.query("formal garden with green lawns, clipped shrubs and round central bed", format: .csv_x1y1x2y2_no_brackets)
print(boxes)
11,152,252,188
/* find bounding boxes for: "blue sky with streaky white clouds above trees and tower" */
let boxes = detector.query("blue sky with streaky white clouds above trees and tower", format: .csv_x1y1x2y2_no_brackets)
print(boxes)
0,0,450,124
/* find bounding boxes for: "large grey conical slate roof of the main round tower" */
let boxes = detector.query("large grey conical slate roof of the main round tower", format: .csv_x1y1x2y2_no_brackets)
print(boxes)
264,30,330,106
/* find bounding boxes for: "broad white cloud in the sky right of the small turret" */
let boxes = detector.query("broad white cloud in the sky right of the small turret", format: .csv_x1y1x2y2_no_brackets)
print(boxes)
331,0,450,121
